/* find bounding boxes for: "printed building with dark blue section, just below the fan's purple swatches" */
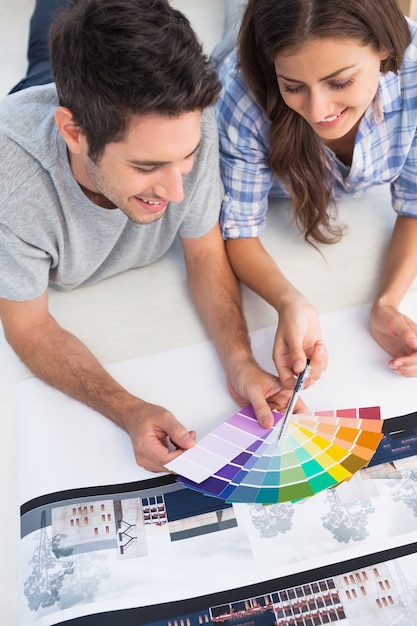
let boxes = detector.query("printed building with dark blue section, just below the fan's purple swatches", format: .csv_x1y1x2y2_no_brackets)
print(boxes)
51,480,237,559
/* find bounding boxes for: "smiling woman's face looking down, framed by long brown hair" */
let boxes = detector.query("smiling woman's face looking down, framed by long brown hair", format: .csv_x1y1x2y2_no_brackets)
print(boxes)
274,38,388,141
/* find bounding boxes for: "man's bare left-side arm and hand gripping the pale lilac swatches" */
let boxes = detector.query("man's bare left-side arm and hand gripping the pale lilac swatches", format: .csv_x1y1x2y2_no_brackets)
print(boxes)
0,292,194,471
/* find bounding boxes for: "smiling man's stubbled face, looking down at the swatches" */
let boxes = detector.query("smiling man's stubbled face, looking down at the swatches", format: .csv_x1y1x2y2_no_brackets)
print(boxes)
75,111,201,224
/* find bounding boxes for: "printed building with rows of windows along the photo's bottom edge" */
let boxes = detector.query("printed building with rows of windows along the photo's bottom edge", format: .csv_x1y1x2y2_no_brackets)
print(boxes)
147,563,404,626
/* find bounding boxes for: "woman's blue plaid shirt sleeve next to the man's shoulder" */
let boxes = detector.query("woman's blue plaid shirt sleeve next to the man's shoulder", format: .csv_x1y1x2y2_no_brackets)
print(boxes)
216,55,280,239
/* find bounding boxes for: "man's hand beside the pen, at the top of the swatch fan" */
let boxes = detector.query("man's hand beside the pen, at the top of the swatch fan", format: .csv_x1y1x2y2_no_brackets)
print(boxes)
227,360,307,428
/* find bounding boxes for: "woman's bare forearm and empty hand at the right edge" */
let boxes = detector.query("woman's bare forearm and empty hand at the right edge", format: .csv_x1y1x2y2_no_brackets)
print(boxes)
371,216,417,376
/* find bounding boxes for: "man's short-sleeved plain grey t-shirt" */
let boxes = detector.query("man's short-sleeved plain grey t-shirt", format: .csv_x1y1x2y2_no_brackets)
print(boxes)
0,84,223,301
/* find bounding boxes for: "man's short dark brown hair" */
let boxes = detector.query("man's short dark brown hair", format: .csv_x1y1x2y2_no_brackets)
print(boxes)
50,0,220,161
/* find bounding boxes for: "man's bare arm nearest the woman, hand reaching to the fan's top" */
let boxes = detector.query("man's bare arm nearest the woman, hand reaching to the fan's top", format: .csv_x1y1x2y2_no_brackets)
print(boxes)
181,225,304,427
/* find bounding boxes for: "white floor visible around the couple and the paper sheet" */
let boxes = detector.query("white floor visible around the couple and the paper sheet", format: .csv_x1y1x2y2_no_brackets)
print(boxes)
0,0,417,626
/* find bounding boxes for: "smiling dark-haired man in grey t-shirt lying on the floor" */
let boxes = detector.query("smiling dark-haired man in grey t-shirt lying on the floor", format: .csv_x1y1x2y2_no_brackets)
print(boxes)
0,0,306,471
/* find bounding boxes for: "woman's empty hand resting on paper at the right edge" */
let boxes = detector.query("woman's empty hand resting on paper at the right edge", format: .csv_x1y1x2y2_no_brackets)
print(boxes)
371,304,417,377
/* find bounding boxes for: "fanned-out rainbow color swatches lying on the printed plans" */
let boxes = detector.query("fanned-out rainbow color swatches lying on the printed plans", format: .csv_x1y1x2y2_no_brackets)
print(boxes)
167,406,382,504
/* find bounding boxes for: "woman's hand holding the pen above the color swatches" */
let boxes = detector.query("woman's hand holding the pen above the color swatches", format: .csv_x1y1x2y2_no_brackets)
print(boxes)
273,294,328,389
